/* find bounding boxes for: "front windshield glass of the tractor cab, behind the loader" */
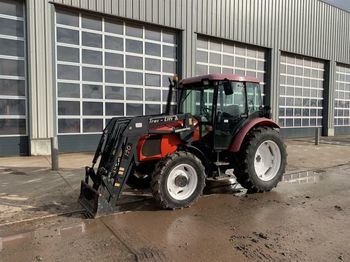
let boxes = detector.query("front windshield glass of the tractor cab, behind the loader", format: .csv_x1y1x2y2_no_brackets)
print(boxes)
179,86,214,121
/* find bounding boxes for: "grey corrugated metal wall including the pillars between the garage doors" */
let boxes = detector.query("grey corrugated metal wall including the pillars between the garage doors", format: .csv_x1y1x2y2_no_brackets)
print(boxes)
27,0,350,145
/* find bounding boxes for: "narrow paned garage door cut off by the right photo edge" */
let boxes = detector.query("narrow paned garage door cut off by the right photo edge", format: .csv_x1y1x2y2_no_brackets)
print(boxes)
334,65,350,133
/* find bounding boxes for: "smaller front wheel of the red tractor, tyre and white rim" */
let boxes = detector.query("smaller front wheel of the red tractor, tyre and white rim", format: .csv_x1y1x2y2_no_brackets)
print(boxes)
151,152,205,209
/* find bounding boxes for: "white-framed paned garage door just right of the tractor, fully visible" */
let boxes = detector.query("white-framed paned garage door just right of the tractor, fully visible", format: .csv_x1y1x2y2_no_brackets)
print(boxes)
279,54,324,131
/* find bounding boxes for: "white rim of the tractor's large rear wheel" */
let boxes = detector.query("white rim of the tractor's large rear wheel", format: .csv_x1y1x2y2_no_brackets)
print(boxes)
254,140,281,181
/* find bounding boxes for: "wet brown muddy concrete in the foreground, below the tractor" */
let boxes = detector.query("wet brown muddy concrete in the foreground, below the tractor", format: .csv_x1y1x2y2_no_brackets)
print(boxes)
0,165,350,261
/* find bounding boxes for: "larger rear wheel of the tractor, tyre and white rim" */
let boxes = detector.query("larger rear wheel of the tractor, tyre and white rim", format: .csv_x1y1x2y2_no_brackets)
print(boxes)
235,127,287,193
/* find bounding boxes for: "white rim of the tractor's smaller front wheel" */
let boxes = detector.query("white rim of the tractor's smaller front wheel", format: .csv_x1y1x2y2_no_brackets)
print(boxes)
167,164,198,200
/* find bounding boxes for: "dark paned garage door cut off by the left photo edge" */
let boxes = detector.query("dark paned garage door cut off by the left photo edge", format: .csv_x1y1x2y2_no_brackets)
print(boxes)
0,0,28,155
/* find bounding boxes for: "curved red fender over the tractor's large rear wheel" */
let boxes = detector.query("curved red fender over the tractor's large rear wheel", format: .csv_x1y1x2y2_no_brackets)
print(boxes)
229,117,280,153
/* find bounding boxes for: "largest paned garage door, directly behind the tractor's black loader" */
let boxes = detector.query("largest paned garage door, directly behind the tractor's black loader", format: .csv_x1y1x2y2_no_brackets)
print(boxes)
56,10,177,138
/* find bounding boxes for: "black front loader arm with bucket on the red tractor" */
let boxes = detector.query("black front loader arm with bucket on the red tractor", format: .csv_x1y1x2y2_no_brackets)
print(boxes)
79,114,194,217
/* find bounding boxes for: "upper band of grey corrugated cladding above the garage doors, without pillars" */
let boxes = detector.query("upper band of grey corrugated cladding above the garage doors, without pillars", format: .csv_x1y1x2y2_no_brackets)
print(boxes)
47,0,350,63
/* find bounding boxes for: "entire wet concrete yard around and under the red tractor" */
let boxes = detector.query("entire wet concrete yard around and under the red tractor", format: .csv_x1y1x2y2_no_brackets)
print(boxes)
0,136,350,261
